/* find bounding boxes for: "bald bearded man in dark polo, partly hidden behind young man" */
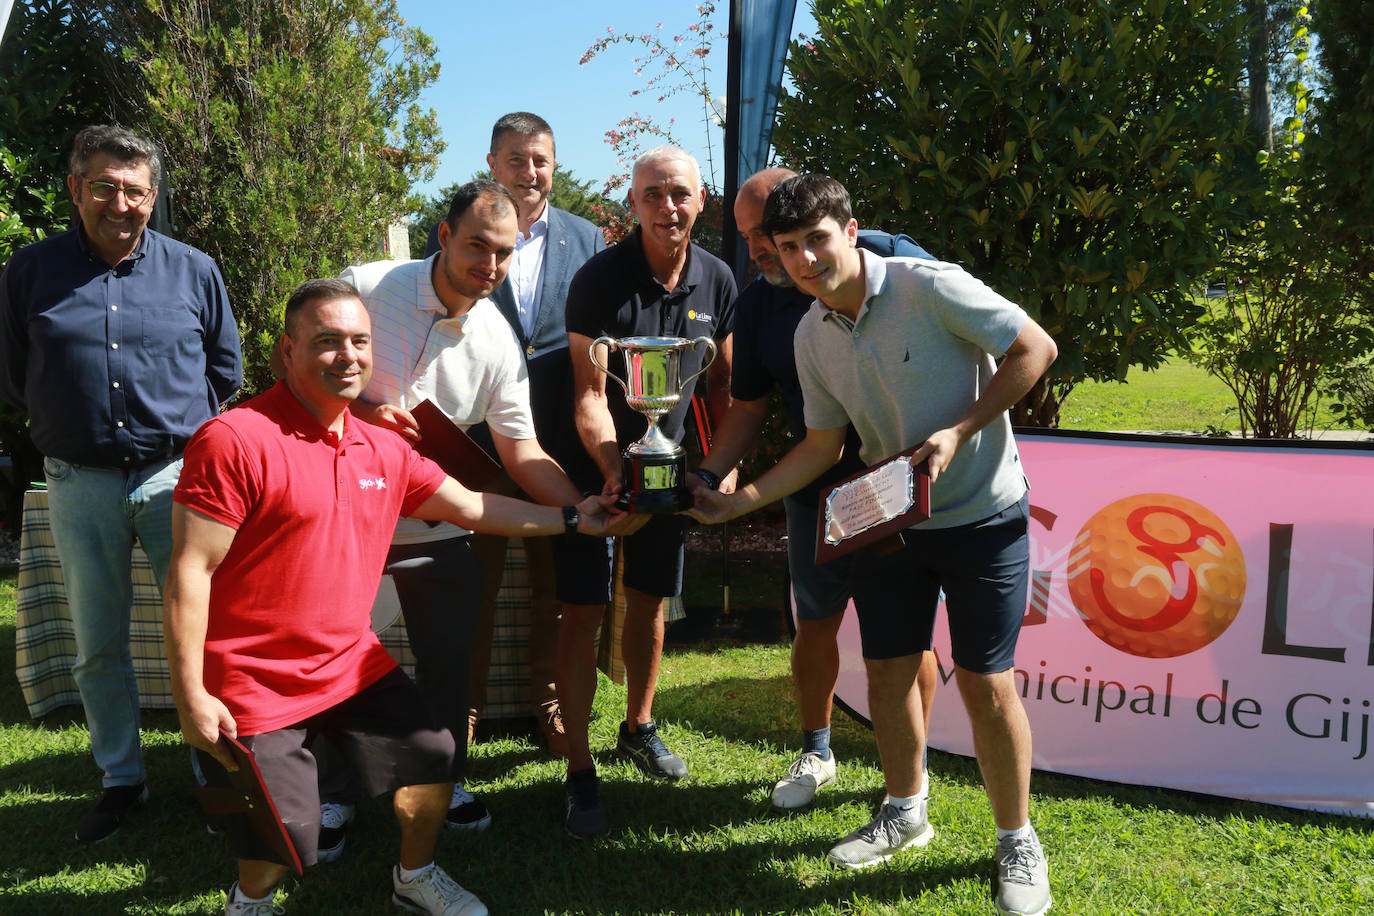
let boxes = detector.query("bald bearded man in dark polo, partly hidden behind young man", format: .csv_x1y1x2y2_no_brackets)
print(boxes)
688,169,938,810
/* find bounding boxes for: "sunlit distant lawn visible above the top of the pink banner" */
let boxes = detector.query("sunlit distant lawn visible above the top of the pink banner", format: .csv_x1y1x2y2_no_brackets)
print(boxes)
1059,358,1336,433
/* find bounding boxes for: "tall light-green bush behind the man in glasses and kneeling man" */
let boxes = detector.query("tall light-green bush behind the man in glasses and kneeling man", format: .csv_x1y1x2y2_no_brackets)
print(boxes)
114,0,442,394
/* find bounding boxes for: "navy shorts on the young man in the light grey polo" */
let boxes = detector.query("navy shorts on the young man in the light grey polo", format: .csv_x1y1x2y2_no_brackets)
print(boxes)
855,496,1031,674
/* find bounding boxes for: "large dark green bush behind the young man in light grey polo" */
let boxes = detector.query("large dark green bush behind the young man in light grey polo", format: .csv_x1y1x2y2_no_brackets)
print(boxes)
775,0,1253,426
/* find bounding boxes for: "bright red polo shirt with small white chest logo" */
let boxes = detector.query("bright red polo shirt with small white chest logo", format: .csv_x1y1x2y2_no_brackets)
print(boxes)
174,382,444,735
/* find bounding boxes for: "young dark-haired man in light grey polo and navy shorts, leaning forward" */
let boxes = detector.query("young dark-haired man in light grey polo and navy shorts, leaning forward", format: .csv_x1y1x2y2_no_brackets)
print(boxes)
692,174,1057,916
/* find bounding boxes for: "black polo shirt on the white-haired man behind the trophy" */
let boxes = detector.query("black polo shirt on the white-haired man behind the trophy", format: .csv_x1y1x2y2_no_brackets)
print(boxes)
567,227,735,489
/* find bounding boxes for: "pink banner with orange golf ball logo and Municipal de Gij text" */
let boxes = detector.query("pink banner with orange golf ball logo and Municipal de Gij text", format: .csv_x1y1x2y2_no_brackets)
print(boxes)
818,431,1374,816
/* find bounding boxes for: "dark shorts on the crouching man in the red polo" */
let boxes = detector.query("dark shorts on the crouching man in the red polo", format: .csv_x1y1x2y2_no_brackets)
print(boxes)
195,667,453,865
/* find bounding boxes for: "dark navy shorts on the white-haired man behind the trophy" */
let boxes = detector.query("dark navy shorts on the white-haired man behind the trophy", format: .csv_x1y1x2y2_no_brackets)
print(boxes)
551,515,687,604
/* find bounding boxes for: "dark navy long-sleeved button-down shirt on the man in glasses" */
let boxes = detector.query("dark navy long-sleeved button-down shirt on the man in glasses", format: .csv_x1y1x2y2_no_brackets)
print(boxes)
0,227,243,468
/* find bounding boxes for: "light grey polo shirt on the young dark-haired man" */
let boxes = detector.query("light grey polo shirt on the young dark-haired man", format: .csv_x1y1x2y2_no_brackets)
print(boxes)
794,249,1026,527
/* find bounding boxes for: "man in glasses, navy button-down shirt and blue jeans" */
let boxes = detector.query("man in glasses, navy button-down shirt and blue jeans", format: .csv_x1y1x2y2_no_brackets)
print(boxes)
0,125,243,843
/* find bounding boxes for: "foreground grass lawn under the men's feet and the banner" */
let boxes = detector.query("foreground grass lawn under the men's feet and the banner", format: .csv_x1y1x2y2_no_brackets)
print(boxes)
0,580,1374,916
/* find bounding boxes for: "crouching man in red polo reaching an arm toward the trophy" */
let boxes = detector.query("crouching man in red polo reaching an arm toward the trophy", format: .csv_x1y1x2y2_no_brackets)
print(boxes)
165,280,625,916
